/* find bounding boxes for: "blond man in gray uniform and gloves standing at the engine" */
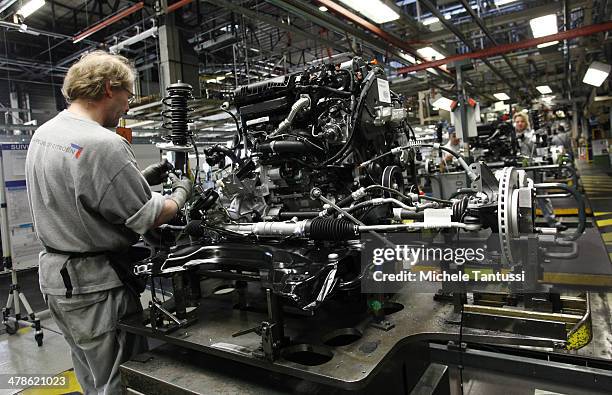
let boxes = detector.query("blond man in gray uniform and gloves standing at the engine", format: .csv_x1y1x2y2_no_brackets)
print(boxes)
26,51,192,395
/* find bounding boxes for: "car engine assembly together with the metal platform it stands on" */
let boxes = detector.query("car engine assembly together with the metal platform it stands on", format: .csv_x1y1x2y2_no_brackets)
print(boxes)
121,58,612,393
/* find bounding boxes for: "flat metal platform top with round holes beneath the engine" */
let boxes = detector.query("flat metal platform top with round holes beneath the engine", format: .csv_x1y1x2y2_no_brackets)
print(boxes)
121,287,612,390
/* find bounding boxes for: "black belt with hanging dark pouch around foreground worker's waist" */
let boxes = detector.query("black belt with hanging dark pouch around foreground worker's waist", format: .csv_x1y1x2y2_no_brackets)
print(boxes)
45,246,146,298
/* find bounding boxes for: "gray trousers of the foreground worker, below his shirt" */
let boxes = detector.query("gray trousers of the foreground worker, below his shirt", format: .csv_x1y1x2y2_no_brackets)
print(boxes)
47,287,147,395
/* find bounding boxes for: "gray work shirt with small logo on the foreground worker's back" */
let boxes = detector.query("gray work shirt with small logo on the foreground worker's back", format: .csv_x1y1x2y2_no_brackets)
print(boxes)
26,110,164,295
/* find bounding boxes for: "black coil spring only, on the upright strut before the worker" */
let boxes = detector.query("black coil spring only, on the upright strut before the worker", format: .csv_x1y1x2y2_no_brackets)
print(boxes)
161,81,193,145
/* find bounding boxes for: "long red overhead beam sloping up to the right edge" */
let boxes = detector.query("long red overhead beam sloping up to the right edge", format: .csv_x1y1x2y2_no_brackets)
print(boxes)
397,22,612,74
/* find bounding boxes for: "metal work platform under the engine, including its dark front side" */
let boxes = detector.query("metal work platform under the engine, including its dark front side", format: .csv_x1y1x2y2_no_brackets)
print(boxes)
121,292,612,394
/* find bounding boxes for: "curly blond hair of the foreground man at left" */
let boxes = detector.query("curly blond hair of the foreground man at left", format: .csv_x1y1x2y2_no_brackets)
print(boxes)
62,50,136,103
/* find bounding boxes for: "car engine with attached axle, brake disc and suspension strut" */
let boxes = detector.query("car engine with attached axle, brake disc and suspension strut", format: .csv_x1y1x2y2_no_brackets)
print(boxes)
135,58,584,346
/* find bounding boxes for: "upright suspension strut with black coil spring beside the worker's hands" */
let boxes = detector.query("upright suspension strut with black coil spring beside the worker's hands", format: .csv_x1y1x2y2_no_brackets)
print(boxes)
157,80,193,175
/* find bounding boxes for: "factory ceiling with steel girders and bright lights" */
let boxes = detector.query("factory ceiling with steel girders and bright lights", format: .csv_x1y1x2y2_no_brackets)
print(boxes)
0,0,612,108
